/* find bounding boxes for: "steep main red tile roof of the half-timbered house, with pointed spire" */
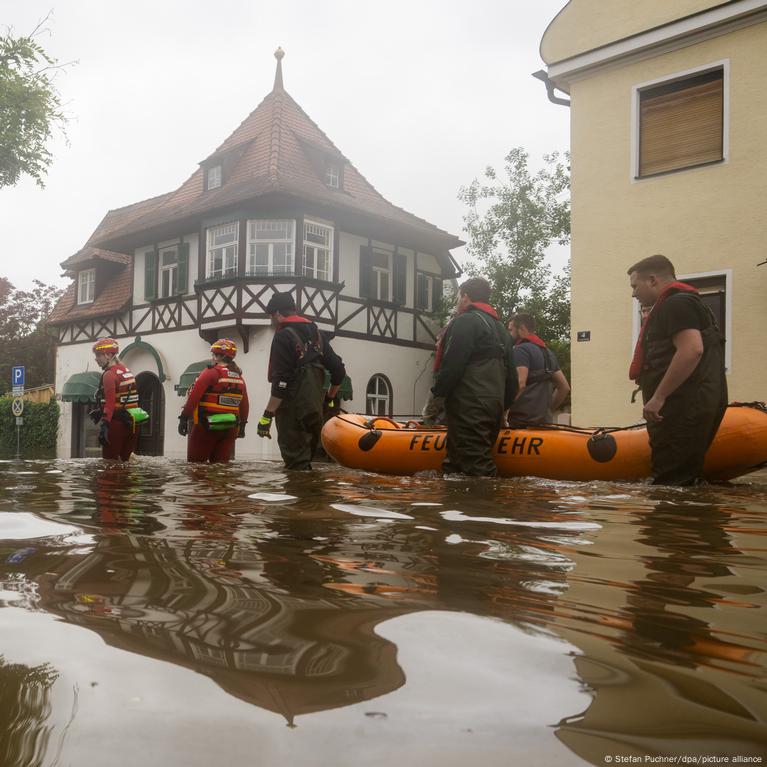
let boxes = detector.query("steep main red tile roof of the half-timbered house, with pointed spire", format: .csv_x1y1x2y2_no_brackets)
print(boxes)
88,64,463,248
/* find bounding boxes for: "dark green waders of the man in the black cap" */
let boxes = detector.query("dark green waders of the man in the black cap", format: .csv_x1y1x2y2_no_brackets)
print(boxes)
274,364,325,469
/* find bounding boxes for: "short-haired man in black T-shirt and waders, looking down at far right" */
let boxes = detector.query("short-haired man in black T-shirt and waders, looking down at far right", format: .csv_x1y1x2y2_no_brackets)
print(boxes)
628,255,727,485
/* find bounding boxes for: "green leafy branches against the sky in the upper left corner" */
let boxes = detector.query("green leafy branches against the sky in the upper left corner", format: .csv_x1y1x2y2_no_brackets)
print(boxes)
0,21,66,188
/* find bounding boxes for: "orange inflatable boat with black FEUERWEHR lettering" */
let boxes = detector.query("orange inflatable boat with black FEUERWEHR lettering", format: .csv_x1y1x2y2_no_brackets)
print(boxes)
322,403,767,480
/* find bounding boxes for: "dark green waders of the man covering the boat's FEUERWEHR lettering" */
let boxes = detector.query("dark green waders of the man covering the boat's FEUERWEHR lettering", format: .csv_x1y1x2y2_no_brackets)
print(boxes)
440,359,506,477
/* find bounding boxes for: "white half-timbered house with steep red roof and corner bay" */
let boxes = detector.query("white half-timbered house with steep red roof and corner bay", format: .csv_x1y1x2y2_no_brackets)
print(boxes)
54,50,463,458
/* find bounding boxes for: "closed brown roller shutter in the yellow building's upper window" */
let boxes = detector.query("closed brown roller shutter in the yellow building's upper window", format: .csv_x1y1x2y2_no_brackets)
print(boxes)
639,70,723,176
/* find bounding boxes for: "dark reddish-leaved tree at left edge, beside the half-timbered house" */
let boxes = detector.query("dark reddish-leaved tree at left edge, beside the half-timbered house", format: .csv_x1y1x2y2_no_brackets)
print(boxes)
0,277,62,394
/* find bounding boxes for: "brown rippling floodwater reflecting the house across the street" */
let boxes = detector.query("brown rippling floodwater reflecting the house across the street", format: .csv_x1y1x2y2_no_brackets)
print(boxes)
0,457,767,767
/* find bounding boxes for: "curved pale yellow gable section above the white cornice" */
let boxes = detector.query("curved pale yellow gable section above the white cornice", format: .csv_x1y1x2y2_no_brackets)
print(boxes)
541,0,726,64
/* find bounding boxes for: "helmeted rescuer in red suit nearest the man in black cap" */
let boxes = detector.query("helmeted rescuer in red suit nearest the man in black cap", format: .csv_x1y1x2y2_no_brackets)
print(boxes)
178,338,250,463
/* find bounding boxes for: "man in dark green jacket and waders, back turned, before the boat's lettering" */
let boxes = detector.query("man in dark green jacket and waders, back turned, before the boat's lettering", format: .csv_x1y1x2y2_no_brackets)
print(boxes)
432,277,519,477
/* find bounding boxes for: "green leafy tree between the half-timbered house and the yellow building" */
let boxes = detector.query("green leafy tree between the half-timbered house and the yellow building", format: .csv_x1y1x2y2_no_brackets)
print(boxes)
458,147,570,344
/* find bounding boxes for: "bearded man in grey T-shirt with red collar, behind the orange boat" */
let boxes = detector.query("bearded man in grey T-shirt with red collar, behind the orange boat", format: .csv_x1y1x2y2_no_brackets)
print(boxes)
507,314,570,429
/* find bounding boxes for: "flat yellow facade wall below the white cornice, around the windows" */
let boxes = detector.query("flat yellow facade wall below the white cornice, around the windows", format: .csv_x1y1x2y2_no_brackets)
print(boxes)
571,23,767,425
